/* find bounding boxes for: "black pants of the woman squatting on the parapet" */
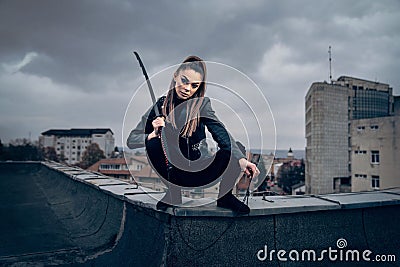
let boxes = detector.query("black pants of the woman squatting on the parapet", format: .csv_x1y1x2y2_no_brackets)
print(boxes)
146,138,240,197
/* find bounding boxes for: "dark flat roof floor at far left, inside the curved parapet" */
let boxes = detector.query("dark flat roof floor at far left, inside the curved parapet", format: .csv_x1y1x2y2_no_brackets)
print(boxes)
0,165,78,257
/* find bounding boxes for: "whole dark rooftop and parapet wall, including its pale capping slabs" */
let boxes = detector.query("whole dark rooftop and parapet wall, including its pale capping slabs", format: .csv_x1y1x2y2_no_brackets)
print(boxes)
0,163,400,266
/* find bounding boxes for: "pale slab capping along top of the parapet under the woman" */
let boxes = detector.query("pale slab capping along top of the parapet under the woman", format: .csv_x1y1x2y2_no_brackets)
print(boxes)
38,163,400,217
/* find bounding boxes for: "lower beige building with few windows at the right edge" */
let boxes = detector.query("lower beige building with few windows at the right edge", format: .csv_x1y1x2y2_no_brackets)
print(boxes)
351,116,400,192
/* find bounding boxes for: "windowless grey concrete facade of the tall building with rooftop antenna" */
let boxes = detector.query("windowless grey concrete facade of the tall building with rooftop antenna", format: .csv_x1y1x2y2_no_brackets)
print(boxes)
305,83,350,194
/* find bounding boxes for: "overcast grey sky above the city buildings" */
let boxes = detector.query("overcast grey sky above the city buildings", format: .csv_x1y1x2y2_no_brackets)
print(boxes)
0,0,400,149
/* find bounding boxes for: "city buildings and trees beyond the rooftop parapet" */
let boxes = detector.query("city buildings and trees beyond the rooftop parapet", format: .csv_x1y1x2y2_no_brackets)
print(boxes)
0,76,400,198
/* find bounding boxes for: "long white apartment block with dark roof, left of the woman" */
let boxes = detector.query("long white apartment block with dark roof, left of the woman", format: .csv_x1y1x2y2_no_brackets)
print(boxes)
39,128,115,164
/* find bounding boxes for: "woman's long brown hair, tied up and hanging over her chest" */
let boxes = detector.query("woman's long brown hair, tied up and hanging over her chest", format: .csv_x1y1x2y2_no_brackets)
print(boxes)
162,56,207,137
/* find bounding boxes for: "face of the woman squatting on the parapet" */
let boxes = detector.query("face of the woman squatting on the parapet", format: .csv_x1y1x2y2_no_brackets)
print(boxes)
174,69,203,100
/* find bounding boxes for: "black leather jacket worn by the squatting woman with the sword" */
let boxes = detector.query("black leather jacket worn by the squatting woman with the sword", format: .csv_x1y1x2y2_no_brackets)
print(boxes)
127,96,245,160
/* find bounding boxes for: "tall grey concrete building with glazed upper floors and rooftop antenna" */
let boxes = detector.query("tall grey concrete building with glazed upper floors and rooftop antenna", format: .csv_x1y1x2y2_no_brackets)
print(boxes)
305,76,395,194
